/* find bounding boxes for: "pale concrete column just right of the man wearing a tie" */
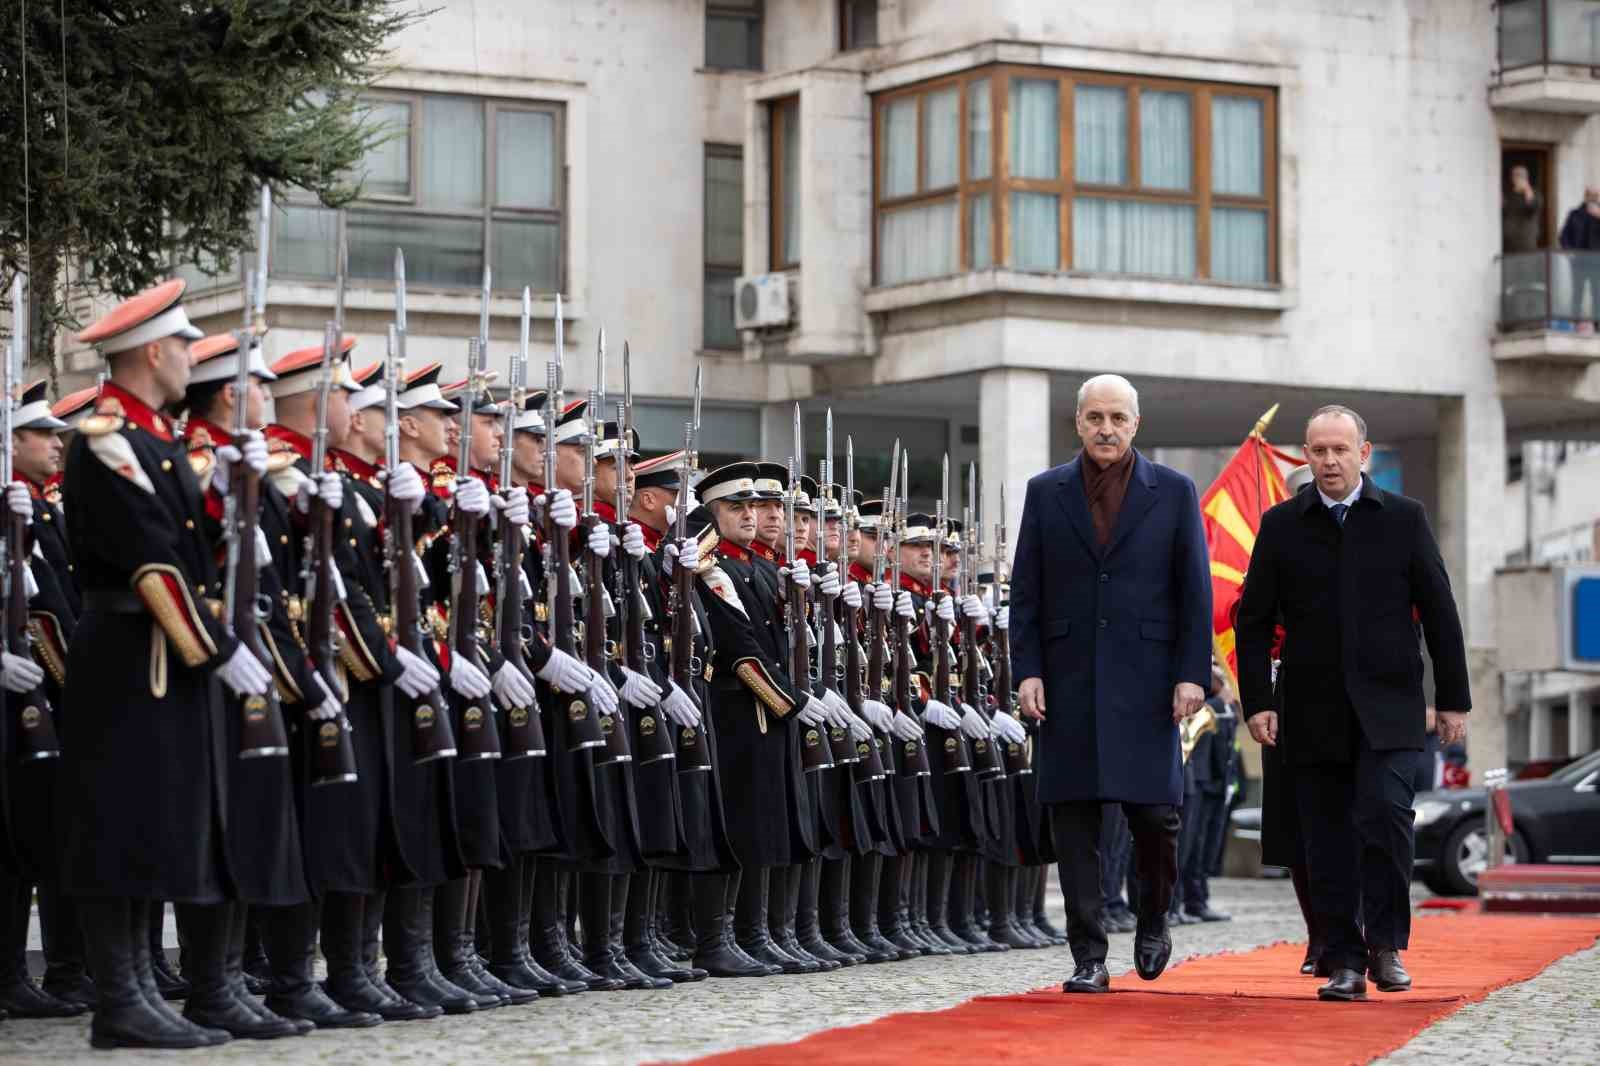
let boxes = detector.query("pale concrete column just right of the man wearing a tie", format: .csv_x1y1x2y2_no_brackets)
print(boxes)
1429,391,1506,781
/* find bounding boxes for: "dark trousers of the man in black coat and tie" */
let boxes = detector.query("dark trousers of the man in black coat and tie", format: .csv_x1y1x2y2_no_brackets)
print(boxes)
1294,736,1416,972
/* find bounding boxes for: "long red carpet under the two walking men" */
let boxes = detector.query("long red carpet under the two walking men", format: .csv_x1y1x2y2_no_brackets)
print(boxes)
681,914,1600,1066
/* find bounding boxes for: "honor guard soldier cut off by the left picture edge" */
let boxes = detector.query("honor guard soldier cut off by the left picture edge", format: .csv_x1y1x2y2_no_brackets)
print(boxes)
0,381,94,1018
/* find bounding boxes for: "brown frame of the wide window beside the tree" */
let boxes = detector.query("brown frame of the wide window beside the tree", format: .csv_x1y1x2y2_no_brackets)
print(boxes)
272,90,570,291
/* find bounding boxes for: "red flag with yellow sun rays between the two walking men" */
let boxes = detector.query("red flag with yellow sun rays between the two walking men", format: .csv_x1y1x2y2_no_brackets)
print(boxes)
1200,403,1294,691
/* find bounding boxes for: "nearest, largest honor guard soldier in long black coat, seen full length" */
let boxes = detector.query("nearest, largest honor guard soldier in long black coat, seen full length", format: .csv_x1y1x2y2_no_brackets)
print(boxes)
61,279,286,1047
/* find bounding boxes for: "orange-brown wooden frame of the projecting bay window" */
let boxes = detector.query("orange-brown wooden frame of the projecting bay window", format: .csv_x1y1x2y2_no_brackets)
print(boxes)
870,64,1282,288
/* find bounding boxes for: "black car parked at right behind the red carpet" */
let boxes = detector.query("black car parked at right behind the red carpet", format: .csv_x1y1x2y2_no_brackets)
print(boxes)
1411,751,1600,896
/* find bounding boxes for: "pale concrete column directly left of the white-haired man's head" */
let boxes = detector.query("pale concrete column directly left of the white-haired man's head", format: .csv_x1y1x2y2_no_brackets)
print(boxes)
978,368,1053,569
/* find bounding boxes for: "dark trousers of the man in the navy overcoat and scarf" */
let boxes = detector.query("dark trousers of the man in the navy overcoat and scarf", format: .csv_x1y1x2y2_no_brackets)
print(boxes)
1050,800,1178,965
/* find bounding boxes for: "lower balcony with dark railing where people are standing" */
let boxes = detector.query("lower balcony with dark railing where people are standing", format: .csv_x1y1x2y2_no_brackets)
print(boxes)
1491,251,1600,363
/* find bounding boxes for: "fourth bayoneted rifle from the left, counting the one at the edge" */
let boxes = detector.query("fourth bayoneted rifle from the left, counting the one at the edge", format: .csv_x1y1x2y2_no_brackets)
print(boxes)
384,248,456,765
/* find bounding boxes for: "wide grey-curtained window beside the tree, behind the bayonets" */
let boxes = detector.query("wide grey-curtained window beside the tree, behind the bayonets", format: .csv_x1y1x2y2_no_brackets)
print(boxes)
272,94,565,291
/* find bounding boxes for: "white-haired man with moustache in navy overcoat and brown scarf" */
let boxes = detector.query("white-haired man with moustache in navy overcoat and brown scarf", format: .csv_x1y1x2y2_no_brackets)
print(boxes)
1011,375,1211,992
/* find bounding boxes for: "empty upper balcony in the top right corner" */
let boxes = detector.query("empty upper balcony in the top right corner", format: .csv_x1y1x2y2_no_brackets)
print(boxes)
1490,0,1600,115
